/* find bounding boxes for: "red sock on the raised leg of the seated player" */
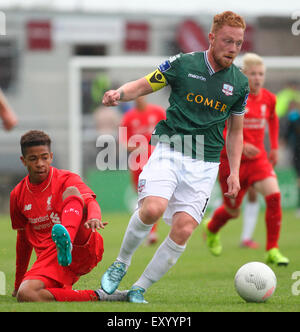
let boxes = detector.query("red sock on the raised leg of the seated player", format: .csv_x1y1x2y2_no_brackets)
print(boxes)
61,195,83,242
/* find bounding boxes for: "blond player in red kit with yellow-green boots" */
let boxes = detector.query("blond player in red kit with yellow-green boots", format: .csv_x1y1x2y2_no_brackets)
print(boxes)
204,53,289,265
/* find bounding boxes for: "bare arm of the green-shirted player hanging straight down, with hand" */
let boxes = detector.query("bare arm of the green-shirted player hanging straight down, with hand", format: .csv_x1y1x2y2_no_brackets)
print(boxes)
225,115,244,198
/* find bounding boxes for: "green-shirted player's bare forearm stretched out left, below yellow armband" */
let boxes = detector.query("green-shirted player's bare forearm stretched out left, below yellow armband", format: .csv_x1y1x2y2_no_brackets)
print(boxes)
102,77,153,106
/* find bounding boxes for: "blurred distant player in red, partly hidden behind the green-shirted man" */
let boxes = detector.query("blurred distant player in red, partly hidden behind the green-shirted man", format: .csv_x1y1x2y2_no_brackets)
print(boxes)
120,96,166,244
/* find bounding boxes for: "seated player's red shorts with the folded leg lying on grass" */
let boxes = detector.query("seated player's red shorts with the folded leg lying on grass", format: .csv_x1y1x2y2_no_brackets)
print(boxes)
17,228,127,302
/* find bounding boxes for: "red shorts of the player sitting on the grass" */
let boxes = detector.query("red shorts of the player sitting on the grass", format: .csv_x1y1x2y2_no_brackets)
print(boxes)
23,232,104,288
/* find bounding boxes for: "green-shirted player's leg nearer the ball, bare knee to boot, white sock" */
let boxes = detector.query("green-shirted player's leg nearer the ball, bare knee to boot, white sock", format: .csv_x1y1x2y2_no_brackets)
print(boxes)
128,212,198,303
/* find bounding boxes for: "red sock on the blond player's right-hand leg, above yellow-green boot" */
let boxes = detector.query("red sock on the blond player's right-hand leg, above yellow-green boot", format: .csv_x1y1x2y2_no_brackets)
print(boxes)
265,193,282,250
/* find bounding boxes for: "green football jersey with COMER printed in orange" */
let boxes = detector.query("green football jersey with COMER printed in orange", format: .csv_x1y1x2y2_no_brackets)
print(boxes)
152,51,249,162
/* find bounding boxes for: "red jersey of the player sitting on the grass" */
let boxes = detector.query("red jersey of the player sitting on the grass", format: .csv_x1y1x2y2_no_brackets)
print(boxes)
10,167,96,256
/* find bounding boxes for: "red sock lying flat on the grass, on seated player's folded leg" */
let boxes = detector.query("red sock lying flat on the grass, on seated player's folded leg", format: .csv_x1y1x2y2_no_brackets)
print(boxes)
46,288,99,302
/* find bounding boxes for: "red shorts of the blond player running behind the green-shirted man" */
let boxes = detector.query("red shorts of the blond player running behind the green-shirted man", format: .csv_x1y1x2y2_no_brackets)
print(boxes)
219,156,276,209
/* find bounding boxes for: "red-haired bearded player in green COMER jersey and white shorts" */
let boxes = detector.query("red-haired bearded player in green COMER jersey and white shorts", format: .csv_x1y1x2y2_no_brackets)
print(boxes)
101,11,249,303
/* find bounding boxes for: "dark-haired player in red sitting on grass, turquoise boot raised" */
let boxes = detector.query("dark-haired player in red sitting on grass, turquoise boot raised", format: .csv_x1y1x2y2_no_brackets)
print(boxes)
10,130,126,302
